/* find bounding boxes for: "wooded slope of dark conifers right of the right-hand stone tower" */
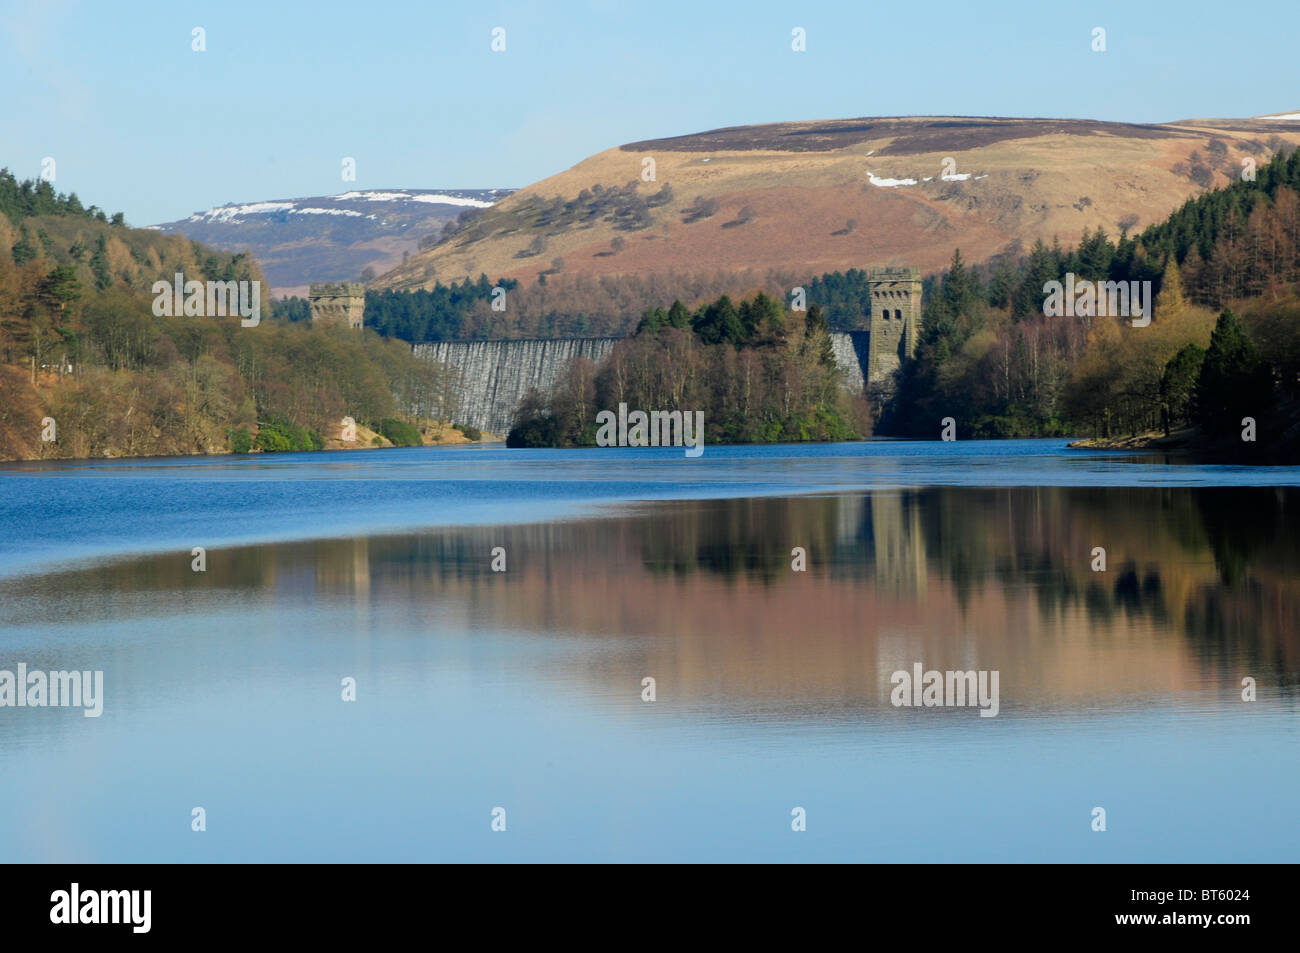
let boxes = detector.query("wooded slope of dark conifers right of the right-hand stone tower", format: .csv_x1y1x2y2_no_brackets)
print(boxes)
879,153,1300,447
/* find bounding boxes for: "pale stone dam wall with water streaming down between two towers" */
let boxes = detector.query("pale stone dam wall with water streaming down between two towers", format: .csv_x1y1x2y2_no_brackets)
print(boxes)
413,332,871,436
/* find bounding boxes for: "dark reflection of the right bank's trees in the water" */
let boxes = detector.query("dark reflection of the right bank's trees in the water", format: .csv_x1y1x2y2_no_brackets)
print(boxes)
917,488,1300,657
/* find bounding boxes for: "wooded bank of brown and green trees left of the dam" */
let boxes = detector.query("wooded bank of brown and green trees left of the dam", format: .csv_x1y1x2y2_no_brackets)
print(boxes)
0,177,456,459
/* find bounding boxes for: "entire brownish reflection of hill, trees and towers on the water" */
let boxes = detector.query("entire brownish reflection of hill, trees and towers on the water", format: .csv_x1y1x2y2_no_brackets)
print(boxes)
0,488,1300,712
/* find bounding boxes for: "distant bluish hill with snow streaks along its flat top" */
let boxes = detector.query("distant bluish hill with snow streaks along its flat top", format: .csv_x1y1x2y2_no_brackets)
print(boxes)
151,189,512,296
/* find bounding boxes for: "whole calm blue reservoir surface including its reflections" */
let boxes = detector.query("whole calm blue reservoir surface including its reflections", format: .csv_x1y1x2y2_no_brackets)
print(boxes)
0,441,1300,862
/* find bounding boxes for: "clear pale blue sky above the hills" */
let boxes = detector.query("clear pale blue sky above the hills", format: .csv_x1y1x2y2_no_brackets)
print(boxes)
0,0,1300,225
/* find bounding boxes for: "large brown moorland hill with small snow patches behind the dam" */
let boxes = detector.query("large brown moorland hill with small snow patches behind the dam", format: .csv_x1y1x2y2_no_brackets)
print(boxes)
372,113,1300,290
